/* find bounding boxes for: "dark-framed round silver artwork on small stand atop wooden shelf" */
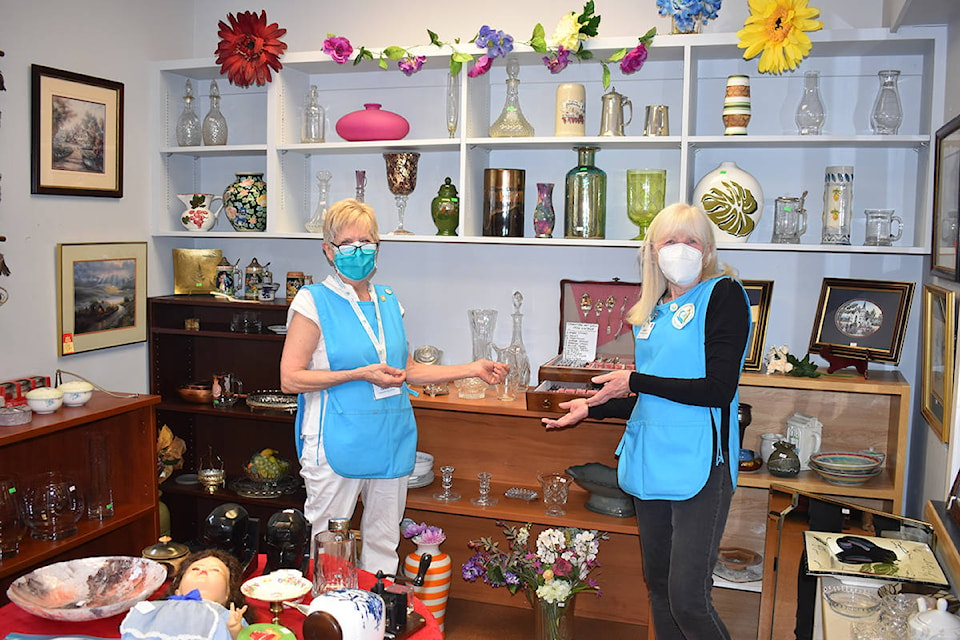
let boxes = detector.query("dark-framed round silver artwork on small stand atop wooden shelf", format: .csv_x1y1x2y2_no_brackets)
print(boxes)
810,278,915,364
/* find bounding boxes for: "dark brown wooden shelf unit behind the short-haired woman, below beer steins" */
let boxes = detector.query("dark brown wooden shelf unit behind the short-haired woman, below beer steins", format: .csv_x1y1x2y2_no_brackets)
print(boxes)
148,296,305,541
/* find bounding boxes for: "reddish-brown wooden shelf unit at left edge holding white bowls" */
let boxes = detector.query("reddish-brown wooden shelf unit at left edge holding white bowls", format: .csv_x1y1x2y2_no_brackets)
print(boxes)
0,391,159,604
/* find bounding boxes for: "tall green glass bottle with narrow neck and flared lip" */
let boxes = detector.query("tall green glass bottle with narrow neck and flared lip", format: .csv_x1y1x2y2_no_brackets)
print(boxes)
563,147,607,238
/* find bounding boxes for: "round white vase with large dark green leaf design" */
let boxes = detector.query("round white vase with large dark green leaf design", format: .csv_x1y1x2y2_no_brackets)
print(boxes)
693,162,763,242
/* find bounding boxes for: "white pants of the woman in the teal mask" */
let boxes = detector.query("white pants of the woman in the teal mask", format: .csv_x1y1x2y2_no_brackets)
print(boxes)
300,435,409,573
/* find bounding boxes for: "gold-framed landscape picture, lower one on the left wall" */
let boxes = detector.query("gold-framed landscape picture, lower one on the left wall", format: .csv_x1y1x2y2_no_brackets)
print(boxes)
57,242,147,356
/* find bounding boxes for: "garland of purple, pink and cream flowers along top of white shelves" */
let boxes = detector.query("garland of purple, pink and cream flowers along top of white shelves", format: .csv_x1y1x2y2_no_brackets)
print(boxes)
323,0,656,89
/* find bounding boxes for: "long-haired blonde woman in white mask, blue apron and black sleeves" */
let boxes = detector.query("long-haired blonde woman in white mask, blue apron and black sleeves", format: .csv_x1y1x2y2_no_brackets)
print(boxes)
543,203,751,640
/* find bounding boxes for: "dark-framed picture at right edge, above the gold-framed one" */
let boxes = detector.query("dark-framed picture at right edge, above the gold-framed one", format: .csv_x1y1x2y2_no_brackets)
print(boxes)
930,116,960,280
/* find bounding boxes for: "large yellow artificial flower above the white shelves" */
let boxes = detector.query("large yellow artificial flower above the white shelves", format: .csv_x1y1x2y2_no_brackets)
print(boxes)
737,0,823,75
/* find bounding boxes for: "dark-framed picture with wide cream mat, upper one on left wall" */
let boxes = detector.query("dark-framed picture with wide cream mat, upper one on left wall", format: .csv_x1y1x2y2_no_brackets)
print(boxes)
30,65,123,198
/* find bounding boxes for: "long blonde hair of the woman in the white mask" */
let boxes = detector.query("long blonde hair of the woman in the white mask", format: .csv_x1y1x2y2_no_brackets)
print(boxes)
627,202,736,325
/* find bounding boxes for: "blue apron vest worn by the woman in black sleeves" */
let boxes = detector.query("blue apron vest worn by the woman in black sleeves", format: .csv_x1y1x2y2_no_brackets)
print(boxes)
617,278,750,500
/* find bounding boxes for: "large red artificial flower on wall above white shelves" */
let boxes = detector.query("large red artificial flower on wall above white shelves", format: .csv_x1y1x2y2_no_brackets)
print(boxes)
216,11,287,87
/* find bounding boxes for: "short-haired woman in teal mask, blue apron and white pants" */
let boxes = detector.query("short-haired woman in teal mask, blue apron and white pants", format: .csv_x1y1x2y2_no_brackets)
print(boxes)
280,200,506,573
